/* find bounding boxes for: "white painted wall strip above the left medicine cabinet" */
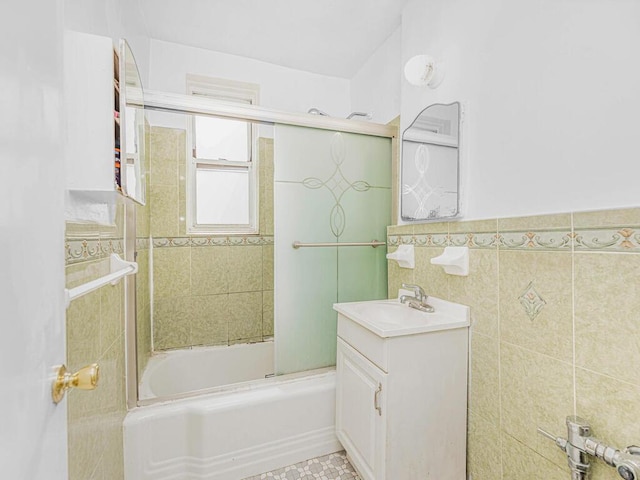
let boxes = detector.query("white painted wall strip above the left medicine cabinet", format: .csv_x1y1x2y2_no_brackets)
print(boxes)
64,0,149,85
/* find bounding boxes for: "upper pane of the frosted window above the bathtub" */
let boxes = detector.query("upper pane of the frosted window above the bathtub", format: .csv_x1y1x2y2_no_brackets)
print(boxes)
194,117,251,162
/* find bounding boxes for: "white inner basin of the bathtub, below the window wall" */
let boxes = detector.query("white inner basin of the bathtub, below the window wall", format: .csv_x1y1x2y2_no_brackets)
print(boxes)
140,341,273,399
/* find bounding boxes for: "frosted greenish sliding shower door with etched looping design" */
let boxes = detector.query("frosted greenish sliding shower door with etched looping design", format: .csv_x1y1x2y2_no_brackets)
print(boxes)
274,125,392,374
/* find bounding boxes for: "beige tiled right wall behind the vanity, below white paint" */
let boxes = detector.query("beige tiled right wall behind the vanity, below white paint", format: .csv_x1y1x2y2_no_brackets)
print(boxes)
388,209,640,480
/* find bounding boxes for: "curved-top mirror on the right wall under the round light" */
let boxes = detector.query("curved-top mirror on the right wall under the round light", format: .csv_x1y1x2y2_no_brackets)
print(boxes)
401,102,460,221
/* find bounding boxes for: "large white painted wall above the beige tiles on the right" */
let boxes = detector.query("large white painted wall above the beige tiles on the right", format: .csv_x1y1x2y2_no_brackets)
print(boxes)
402,0,640,219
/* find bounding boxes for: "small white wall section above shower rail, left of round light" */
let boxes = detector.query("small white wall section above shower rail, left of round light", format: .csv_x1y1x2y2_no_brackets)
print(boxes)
350,27,402,123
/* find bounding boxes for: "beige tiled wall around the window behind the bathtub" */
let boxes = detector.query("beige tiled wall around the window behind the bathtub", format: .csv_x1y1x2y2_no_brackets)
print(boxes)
150,127,273,350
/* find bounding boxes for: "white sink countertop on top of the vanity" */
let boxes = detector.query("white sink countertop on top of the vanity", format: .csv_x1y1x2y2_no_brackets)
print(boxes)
333,297,469,338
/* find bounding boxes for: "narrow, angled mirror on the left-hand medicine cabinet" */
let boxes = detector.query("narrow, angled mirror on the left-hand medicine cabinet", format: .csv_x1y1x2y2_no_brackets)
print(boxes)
120,40,146,205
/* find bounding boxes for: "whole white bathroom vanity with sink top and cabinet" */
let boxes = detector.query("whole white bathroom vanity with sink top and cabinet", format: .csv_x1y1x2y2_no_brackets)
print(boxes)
334,297,469,480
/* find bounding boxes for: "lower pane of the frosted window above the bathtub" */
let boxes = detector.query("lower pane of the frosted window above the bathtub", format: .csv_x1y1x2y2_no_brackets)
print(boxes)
196,167,250,225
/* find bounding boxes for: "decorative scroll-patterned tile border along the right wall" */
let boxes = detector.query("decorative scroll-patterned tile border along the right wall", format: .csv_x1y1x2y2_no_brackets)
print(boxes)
387,227,640,253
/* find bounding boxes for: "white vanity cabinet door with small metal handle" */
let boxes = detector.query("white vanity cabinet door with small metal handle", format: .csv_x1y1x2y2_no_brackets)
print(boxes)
336,338,387,480
